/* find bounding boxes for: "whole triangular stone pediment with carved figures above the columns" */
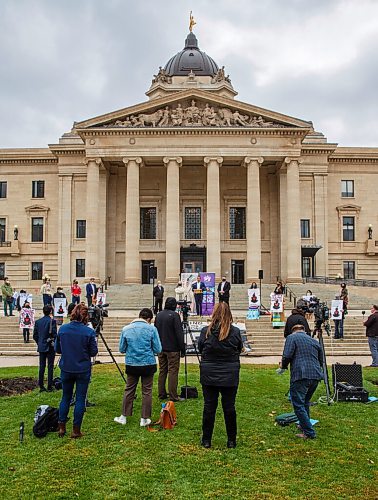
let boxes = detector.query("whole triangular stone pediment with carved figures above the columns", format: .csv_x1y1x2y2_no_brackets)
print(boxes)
74,90,313,132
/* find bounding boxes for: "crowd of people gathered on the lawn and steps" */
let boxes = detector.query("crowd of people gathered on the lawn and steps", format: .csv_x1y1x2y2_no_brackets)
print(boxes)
2,276,378,448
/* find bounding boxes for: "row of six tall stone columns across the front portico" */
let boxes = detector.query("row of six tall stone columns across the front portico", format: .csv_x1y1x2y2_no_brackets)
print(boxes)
76,157,301,283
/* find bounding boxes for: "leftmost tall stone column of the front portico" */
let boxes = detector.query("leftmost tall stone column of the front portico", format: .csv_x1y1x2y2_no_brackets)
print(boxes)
85,158,102,280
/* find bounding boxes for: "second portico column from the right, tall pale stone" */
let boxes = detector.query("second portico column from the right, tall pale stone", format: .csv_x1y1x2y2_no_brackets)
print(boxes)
244,156,264,283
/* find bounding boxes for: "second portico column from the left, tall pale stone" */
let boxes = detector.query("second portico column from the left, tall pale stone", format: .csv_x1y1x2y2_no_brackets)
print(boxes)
123,156,142,283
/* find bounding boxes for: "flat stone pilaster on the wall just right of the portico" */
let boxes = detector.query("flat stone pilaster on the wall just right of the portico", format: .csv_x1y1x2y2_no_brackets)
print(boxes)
314,174,328,276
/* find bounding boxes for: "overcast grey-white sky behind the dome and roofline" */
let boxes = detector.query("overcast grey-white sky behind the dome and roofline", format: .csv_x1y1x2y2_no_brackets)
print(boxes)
0,0,378,147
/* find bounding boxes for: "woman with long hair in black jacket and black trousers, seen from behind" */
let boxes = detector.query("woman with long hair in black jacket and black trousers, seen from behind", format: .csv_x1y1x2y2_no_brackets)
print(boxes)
198,302,243,448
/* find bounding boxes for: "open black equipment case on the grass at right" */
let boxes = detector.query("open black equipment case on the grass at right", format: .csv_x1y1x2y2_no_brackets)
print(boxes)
332,363,369,403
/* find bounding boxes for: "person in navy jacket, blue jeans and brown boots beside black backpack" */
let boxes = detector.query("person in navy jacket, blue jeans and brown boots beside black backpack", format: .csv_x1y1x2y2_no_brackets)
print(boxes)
55,304,98,439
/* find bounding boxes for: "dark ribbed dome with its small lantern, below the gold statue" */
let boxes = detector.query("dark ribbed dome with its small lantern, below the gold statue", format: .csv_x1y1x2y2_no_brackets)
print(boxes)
164,33,219,76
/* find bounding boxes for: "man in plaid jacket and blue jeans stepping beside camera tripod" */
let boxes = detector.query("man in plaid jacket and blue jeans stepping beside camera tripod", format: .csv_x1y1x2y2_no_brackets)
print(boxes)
280,325,323,439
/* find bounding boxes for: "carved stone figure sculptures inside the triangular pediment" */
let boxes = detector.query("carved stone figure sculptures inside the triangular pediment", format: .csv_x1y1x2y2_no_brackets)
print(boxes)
105,100,288,128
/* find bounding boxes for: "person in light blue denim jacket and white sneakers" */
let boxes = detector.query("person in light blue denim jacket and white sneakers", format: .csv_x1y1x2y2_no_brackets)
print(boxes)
114,308,161,427
